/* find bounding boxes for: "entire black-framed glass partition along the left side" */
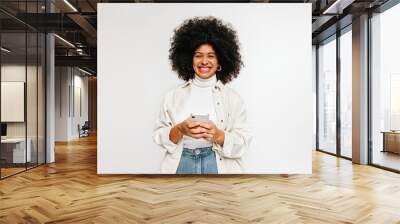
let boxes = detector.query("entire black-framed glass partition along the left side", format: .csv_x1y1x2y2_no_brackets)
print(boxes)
0,1,46,179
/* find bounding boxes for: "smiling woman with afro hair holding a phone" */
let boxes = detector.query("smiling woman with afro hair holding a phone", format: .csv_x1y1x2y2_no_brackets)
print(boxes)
153,17,251,174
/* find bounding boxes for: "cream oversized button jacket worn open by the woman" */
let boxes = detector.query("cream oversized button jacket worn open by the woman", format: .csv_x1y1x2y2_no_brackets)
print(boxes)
153,81,252,174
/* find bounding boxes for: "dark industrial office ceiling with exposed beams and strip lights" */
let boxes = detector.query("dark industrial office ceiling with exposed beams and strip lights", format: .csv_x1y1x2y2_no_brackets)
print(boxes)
0,0,389,75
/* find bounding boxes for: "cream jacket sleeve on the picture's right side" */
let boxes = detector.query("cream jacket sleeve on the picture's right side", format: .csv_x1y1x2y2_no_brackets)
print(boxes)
217,96,252,159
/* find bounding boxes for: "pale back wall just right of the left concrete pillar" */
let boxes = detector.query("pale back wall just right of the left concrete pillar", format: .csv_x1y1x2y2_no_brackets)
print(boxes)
55,67,88,141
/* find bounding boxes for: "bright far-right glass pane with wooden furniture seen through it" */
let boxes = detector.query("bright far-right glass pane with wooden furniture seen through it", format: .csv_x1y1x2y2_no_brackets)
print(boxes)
370,4,400,171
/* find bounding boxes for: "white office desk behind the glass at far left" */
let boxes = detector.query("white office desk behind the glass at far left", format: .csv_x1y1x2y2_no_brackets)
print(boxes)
1,138,32,163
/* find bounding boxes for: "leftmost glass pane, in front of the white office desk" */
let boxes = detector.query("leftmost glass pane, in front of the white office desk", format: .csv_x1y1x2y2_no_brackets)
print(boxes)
0,32,27,178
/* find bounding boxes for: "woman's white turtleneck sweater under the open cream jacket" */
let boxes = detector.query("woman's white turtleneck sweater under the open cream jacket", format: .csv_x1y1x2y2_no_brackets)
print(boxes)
181,75,217,149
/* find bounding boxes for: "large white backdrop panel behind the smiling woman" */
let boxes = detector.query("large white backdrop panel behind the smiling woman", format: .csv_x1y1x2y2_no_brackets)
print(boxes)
97,3,313,174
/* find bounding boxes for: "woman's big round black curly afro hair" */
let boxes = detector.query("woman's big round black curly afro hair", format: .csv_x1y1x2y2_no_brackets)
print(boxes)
169,17,243,84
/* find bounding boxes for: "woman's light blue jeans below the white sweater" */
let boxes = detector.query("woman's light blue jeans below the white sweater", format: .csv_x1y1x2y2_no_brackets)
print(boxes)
176,147,218,174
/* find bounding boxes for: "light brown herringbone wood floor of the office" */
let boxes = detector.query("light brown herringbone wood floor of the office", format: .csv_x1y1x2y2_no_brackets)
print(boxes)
0,134,400,224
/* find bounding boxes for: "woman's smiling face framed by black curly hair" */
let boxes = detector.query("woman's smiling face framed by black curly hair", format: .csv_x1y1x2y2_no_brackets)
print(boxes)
193,44,219,79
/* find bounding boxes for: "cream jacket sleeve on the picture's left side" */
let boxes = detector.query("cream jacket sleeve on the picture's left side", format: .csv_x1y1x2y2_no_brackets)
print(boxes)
153,96,178,153
